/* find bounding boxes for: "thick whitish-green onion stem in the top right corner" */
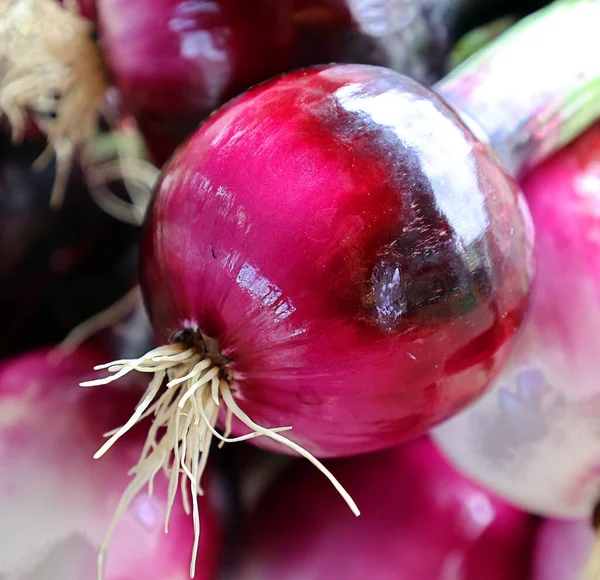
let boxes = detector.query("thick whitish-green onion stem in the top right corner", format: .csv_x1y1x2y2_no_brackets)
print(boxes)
434,0,600,178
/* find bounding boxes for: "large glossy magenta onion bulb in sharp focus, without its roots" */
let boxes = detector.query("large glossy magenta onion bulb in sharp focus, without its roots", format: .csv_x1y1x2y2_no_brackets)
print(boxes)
141,65,532,457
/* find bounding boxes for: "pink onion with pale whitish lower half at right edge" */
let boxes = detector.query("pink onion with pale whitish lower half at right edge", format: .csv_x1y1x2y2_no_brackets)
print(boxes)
437,124,600,518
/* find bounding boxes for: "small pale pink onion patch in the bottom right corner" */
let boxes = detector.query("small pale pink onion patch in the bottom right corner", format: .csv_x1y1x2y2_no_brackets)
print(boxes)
532,519,594,580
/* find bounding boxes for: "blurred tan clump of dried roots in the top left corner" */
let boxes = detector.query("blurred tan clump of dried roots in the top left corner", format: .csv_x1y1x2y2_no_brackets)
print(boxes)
0,0,108,206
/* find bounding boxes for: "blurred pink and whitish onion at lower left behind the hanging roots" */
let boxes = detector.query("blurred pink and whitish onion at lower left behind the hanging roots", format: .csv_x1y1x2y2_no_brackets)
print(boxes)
0,344,223,580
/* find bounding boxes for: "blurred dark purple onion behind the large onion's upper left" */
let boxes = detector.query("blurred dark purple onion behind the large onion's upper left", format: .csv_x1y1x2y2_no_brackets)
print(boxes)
97,0,292,164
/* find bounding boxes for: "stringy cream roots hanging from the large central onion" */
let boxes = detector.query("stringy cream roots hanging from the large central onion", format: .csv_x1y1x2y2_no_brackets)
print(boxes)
81,343,360,580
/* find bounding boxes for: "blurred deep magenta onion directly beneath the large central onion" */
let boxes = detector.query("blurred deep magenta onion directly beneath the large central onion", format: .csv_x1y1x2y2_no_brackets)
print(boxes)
236,440,535,580
